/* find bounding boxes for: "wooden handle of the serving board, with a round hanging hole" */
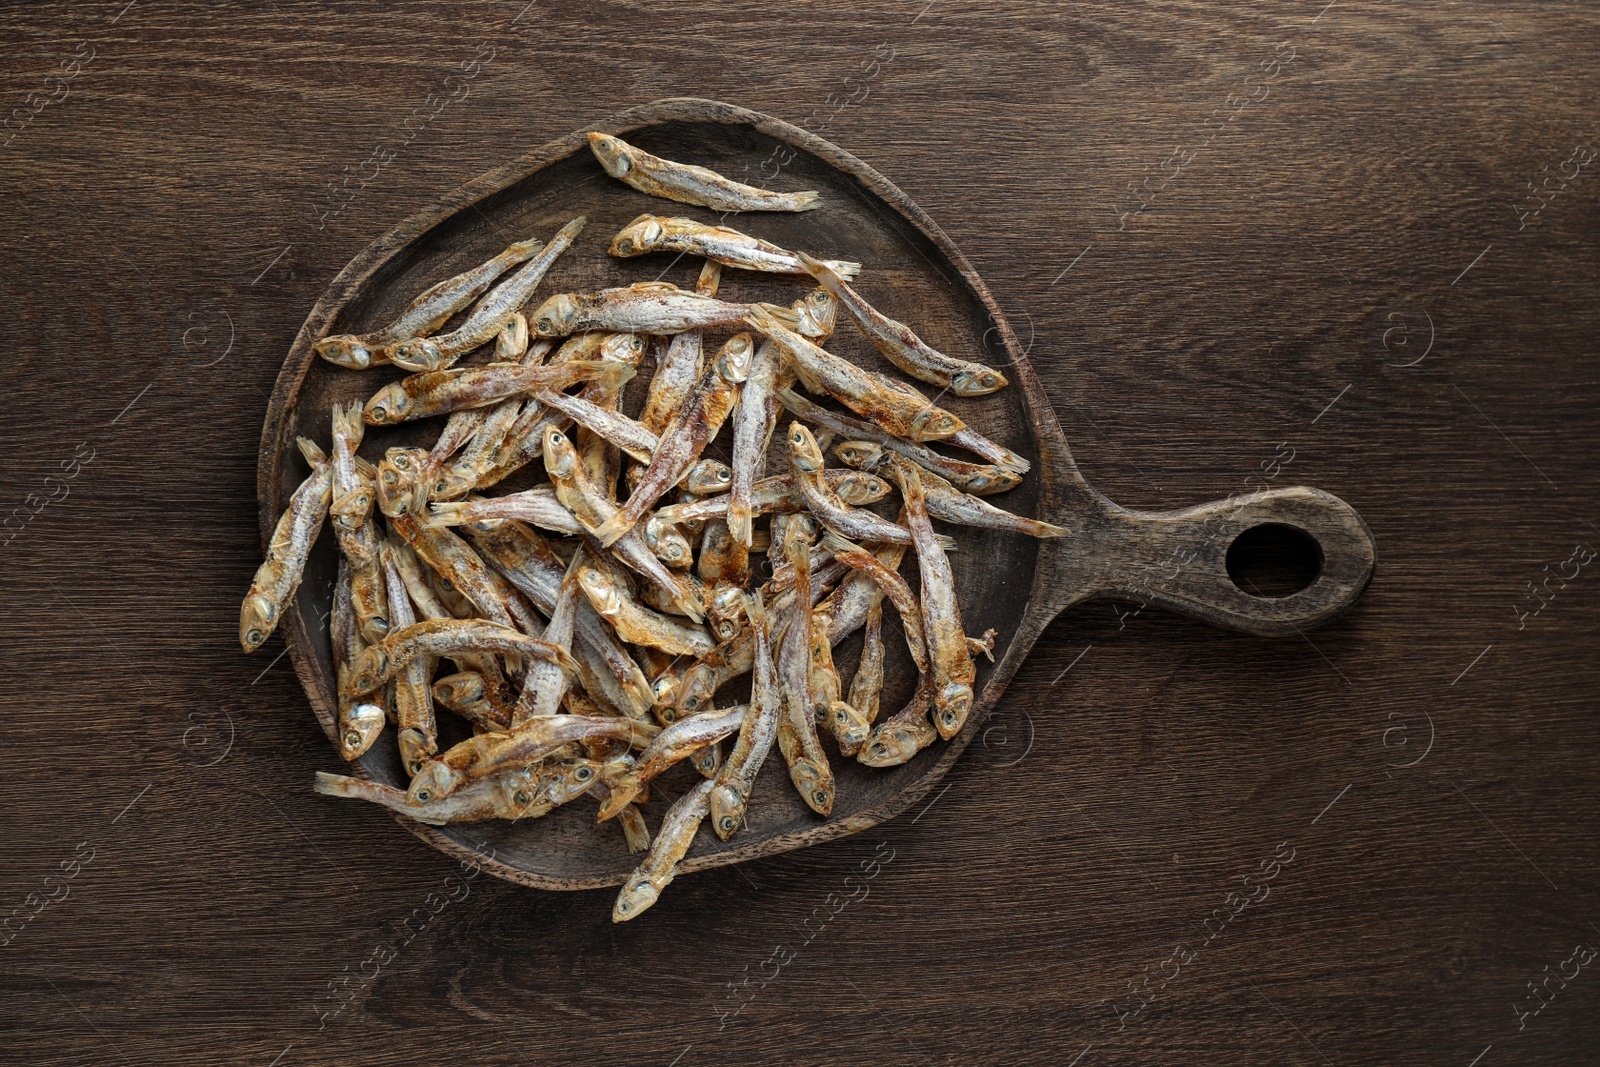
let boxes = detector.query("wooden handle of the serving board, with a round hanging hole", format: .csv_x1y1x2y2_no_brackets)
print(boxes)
1085,486,1376,637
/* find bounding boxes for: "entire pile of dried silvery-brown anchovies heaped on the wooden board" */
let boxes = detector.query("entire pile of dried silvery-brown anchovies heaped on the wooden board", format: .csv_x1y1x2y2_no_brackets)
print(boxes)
240,133,1066,921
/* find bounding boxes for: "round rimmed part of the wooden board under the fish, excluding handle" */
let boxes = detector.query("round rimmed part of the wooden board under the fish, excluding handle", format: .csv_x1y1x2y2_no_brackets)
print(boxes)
259,99,1070,889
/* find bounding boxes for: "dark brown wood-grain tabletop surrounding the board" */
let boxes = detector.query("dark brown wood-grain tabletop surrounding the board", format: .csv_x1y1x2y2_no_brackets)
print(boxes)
0,0,1600,1067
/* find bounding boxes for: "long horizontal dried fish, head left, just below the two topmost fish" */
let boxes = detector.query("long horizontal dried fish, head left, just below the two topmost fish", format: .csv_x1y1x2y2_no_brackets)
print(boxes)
530,282,800,338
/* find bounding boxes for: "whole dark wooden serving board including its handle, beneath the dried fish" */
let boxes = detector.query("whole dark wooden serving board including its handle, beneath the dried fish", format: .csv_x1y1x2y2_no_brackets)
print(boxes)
258,99,1374,889
